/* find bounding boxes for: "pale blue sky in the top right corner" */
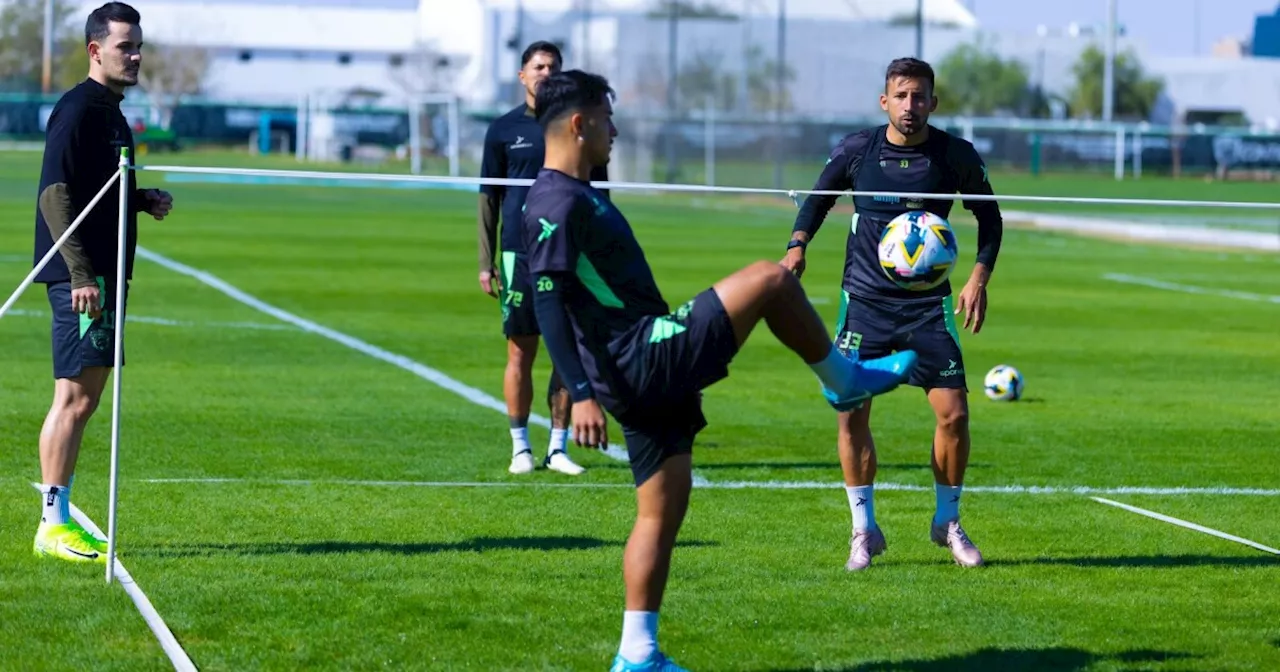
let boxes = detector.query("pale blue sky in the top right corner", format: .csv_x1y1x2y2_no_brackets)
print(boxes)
960,0,1280,56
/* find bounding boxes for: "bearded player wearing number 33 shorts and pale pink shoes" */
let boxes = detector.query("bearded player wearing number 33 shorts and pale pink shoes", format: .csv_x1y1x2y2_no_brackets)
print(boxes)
782,59,1004,571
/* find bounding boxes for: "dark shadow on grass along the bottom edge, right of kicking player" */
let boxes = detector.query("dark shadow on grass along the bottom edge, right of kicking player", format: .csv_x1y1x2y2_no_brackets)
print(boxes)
768,646,1196,672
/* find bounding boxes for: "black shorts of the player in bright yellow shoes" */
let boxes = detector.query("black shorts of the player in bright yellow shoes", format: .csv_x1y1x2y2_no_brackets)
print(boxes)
46,278,129,379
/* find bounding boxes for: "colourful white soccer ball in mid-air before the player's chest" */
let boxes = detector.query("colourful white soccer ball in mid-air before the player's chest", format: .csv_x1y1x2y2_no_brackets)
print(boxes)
879,210,959,292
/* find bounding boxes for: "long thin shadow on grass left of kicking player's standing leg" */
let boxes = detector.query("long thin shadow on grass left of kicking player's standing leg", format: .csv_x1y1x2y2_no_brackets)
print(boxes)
138,536,719,559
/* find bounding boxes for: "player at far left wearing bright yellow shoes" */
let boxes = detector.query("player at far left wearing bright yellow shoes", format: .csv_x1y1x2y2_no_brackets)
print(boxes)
35,3,173,563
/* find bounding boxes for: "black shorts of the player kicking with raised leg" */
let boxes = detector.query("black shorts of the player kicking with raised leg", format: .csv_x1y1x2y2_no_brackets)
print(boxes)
616,289,737,486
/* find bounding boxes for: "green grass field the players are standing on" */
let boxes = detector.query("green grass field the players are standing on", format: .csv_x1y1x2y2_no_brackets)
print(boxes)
0,147,1280,672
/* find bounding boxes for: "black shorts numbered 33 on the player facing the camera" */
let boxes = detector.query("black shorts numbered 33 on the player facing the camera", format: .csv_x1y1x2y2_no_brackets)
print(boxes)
836,292,968,390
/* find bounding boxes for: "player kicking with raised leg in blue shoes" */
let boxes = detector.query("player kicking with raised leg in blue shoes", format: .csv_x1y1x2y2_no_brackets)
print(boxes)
524,70,915,671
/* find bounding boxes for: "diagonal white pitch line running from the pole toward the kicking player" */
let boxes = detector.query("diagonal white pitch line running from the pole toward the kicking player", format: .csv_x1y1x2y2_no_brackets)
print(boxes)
137,246,628,462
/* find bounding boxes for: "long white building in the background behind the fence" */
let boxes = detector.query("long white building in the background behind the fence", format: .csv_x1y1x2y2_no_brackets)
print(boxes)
81,0,975,106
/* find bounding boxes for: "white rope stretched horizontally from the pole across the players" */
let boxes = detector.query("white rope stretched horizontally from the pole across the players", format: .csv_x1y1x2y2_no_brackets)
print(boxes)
133,165,1280,210
